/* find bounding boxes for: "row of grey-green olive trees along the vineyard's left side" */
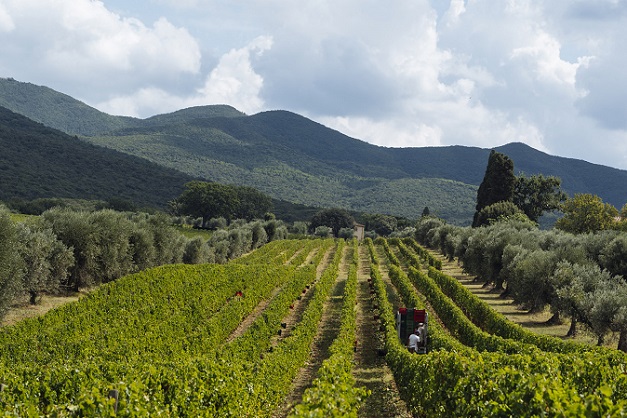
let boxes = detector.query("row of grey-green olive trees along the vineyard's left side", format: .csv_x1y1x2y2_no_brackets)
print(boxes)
0,206,288,317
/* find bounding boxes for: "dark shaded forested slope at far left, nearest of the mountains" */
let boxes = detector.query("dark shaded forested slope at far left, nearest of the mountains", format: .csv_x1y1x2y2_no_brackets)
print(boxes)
0,107,192,208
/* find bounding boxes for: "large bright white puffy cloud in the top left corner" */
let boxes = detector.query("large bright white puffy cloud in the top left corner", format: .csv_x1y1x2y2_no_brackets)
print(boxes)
0,0,200,98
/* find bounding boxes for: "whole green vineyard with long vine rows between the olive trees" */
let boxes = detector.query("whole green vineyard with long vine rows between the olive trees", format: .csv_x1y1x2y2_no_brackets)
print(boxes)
0,239,627,417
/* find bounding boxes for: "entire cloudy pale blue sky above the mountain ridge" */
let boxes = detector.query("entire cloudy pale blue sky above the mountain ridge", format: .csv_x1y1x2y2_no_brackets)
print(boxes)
0,0,627,169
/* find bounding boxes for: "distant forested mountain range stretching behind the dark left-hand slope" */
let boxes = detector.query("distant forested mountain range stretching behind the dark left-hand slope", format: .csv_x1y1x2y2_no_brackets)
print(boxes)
0,79,627,224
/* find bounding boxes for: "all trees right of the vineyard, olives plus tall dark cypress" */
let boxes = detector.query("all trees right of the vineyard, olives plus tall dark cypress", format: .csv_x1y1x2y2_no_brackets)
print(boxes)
422,151,627,351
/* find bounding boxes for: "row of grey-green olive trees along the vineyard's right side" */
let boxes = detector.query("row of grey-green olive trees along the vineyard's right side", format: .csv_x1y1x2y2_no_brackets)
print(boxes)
416,218,627,351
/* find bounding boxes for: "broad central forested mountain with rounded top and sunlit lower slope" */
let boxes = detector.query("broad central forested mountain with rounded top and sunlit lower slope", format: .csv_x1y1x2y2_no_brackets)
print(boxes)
85,112,476,223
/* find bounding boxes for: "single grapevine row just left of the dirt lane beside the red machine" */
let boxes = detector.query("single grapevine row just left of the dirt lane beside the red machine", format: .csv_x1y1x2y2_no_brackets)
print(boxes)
292,240,368,417
